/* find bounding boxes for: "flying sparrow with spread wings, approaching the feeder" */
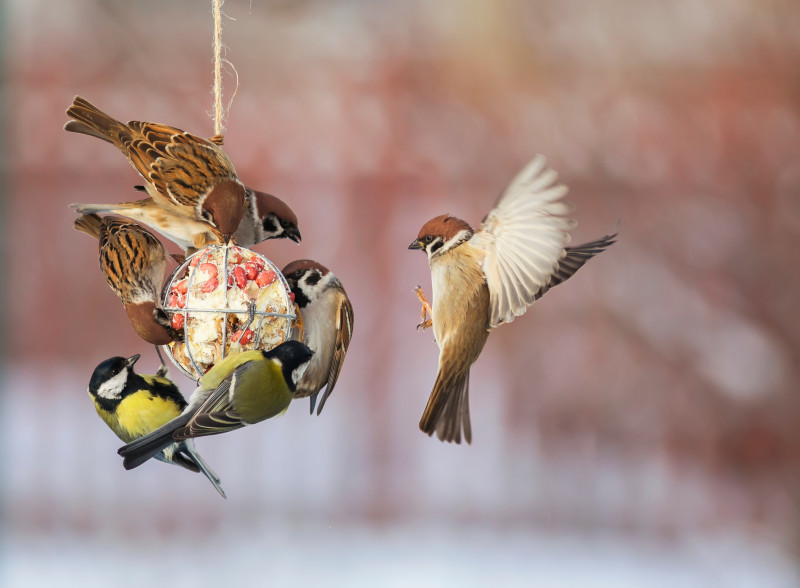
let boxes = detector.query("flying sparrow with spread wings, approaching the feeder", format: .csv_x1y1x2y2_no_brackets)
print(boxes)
409,155,616,443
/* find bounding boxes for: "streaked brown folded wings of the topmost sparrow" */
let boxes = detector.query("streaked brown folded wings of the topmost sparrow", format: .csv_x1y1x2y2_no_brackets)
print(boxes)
124,121,236,216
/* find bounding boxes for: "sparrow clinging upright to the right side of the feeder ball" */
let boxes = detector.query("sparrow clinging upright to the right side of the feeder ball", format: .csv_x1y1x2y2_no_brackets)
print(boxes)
282,259,353,415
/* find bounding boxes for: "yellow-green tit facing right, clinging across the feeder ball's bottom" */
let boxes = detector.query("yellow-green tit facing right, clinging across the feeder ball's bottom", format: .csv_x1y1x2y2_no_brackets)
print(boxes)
118,341,314,470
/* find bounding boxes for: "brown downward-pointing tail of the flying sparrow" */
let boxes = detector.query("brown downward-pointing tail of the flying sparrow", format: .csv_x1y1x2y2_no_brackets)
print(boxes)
419,366,472,443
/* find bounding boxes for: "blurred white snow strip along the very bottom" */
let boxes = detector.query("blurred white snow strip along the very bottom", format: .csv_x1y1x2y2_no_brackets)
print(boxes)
0,525,798,588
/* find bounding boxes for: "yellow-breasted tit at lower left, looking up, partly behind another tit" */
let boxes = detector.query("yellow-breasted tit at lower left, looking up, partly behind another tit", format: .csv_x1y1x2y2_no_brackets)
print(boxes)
89,354,225,498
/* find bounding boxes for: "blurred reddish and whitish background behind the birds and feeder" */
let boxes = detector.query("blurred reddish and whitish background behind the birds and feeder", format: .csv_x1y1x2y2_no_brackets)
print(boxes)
0,0,800,587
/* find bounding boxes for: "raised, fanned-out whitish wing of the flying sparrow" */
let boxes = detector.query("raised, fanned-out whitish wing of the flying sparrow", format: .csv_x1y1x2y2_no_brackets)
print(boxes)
470,155,576,329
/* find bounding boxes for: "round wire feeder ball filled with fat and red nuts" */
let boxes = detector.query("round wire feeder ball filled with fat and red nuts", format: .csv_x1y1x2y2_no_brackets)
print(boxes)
162,245,297,380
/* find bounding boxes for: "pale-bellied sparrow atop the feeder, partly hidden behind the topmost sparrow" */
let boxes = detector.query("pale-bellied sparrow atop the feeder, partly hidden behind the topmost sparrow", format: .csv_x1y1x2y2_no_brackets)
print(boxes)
70,186,300,255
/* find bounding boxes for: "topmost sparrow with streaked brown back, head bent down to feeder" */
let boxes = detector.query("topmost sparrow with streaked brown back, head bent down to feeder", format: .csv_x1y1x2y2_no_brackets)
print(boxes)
64,96,245,241
